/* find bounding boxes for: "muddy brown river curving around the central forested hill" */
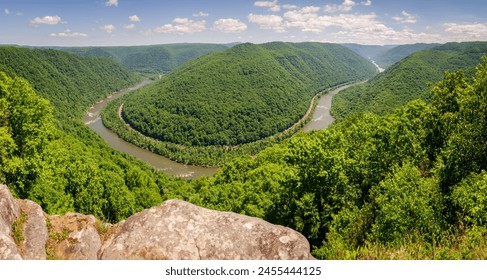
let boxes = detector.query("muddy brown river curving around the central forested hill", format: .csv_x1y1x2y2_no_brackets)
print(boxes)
83,79,362,179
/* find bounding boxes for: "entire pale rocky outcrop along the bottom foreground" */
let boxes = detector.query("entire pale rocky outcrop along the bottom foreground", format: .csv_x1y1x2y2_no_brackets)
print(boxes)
0,185,313,260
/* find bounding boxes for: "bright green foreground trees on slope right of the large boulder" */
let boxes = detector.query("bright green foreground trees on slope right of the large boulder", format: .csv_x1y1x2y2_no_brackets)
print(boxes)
190,58,487,259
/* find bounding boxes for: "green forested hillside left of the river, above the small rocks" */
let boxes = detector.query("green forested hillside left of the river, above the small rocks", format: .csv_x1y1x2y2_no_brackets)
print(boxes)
0,47,189,221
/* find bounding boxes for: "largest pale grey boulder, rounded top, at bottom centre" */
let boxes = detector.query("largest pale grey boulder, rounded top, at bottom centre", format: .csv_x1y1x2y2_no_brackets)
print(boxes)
101,200,313,260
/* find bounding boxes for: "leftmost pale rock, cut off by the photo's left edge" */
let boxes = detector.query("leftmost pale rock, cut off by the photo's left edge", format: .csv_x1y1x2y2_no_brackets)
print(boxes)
0,185,22,260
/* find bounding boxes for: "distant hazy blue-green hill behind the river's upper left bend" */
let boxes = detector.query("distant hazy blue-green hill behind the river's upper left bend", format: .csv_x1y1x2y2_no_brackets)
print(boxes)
62,44,228,74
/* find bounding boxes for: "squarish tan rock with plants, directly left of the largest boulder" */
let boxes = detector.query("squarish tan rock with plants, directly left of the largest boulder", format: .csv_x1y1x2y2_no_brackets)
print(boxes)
47,213,101,260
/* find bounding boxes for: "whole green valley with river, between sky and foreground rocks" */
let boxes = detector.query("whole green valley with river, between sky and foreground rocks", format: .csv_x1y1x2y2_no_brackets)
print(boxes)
0,39,487,259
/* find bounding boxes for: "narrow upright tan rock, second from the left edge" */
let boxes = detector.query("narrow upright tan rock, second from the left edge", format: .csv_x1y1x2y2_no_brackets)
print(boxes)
17,199,49,260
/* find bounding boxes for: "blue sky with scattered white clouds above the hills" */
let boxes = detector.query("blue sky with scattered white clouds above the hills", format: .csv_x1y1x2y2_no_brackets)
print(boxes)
0,0,487,46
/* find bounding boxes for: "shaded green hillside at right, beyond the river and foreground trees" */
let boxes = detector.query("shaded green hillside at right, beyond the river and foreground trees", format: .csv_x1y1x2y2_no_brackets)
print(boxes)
331,42,487,121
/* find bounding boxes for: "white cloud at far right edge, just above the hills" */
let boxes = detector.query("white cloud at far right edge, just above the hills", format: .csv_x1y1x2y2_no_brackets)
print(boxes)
443,23,487,41
